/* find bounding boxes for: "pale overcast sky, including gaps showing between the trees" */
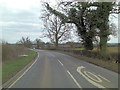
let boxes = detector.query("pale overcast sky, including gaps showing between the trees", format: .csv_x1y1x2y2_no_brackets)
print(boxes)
0,0,118,43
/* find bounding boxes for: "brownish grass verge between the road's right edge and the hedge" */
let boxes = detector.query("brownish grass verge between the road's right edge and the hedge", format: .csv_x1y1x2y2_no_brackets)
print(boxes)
56,50,120,74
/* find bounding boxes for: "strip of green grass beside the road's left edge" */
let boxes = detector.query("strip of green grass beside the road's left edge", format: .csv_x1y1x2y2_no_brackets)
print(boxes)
2,50,35,83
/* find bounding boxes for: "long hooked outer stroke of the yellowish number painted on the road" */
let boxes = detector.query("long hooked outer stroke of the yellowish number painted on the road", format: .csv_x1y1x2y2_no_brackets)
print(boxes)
77,66,105,88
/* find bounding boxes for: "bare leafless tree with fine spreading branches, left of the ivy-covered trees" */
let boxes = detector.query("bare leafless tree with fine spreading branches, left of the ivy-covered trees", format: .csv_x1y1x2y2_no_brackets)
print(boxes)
41,3,72,47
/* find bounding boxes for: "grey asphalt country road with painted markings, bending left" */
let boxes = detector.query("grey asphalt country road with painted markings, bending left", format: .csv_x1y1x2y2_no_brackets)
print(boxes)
11,50,118,88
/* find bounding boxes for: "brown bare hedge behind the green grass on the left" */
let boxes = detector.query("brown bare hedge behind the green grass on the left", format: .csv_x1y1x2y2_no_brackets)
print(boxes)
2,44,29,63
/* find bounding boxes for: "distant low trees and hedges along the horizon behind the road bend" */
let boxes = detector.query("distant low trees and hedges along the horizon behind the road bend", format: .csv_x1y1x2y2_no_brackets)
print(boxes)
16,37,83,49
